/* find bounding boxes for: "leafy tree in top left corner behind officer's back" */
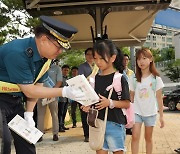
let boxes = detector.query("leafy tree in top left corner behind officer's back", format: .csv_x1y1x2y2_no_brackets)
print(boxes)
0,0,39,45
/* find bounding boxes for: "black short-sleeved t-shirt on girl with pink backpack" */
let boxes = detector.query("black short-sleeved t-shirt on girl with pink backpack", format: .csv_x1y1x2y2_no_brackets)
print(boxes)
95,73,130,124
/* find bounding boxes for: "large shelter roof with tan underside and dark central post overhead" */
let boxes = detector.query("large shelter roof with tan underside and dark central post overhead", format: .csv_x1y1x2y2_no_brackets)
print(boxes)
24,0,171,48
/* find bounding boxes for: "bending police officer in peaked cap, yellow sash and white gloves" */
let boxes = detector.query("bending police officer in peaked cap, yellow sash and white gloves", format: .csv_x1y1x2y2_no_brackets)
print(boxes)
0,16,83,154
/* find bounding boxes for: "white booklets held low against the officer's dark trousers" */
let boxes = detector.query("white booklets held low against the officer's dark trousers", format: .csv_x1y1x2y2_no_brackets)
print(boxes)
8,115,43,144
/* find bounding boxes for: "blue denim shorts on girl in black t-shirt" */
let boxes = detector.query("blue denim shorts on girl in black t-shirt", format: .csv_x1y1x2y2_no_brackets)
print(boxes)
102,121,126,152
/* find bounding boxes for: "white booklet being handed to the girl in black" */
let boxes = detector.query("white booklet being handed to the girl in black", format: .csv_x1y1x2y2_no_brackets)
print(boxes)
66,75,99,106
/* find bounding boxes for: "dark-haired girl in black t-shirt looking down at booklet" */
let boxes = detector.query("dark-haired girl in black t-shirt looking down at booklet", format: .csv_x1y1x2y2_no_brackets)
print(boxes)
84,40,130,154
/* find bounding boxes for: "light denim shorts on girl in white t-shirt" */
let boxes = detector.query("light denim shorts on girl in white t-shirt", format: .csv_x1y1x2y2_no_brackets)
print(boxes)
135,114,157,126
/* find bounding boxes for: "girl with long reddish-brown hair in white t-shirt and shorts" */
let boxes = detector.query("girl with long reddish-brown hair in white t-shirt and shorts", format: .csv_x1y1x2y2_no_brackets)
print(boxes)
130,49,164,154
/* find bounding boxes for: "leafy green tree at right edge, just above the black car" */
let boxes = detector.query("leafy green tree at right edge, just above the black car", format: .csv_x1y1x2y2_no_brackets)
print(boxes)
162,59,180,82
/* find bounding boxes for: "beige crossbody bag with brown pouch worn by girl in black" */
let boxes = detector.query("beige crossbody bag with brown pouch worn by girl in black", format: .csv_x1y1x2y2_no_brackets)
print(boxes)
87,88,113,150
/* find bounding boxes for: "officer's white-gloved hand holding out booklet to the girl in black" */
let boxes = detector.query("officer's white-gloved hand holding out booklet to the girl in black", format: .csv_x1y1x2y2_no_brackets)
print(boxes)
62,86,86,102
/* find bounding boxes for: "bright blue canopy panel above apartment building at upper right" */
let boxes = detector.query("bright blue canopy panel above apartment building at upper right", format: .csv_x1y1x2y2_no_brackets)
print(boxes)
155,8,180,29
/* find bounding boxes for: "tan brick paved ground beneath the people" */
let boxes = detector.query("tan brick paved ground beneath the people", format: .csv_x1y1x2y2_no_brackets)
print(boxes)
12,111,180,154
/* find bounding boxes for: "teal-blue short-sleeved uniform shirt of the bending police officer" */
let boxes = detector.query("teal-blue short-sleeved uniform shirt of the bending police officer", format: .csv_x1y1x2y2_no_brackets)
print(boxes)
0,37,48,95
